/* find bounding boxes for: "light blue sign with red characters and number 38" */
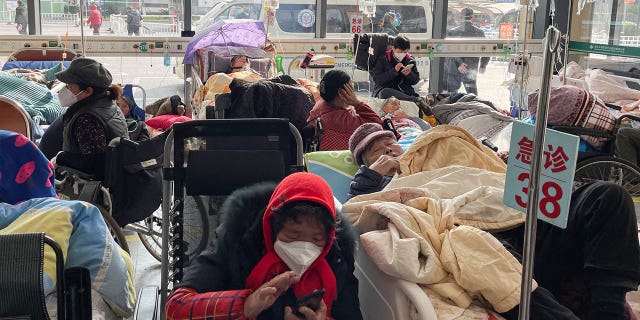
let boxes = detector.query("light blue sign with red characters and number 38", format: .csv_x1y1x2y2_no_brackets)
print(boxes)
503,121,579,229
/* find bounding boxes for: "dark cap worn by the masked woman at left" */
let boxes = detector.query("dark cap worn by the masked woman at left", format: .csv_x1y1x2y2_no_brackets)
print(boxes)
56,58,112,88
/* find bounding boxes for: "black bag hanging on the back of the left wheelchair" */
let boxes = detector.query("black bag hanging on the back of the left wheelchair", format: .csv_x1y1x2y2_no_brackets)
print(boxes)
104,131,169,227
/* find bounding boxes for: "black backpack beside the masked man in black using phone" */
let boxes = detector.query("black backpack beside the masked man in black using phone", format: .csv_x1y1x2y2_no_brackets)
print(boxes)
353,33,395,71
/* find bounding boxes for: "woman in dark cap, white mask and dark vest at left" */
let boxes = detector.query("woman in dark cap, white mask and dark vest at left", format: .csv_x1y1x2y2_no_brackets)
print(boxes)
56,58,129,177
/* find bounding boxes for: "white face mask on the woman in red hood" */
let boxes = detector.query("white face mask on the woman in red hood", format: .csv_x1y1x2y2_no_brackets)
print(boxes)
273,240,322,277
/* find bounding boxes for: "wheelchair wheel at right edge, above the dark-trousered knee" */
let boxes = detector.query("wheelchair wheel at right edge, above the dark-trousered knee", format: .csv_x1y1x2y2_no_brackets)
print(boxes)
573,156,640,198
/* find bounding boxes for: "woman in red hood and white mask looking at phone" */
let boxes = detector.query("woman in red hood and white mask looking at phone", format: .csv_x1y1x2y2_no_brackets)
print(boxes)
165,172,362,320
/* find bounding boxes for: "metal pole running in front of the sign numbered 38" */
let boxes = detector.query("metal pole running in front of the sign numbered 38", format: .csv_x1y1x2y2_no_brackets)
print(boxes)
518,26,561,320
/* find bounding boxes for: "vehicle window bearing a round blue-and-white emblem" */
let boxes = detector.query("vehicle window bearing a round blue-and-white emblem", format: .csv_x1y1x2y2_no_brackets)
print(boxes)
276,4,316,33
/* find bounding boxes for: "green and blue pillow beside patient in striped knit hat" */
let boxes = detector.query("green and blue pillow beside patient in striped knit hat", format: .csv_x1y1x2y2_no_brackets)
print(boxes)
304,150,359,203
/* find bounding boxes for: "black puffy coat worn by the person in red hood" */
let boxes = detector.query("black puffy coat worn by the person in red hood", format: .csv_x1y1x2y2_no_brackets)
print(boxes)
180,183,362,320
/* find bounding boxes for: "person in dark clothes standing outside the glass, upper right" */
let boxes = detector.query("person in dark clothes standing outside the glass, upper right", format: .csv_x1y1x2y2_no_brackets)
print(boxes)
444,8,489,95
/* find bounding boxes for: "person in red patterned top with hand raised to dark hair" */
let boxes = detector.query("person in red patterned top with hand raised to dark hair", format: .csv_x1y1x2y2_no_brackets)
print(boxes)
307,70,382,151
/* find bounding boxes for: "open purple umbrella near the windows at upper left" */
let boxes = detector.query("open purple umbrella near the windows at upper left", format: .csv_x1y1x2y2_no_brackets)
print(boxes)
183,19,267,64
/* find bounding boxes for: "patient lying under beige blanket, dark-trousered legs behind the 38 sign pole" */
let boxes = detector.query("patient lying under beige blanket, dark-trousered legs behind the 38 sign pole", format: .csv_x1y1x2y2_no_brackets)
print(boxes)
343,125,640,319
